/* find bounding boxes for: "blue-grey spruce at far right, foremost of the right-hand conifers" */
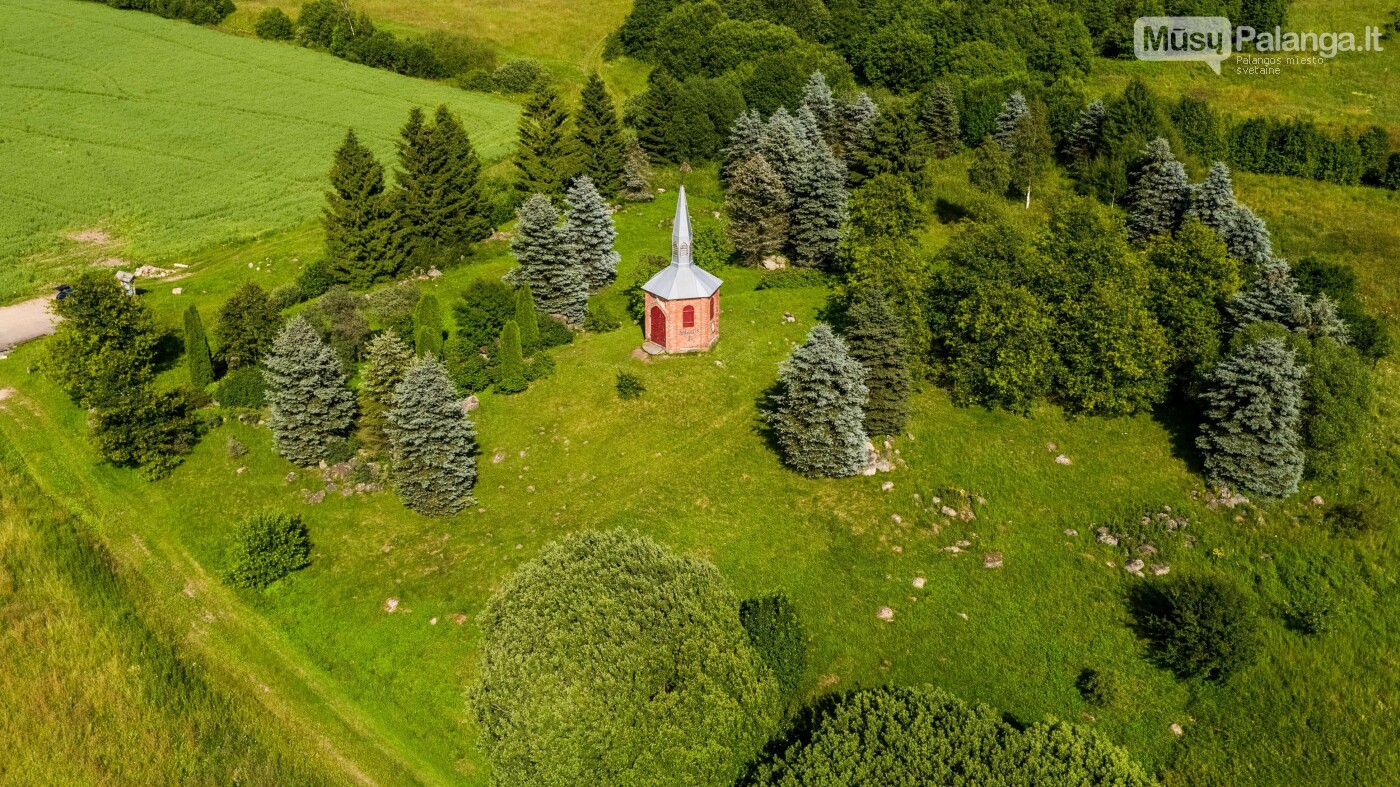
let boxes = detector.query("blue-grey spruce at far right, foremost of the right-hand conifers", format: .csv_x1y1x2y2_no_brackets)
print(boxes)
1196,337,1306,499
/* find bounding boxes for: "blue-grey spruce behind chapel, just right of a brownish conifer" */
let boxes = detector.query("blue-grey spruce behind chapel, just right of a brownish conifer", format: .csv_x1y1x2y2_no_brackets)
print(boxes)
790,133,850,267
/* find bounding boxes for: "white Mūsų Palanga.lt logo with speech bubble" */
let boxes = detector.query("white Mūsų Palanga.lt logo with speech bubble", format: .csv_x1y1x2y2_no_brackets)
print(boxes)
1133,17,1383,74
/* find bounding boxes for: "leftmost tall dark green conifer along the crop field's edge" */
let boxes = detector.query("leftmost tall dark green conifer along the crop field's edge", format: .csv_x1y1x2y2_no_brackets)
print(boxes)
325,130,405,290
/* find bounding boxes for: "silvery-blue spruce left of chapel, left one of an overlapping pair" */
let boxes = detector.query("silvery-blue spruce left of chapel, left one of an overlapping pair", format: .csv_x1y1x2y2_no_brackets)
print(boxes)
508,195,588,323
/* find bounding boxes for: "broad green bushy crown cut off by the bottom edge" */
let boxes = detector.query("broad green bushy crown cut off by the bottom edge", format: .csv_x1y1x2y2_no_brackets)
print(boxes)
755,686,1152,787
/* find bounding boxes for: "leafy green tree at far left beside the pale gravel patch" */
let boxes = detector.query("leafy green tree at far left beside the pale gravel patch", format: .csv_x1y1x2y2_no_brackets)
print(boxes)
42,270,161,408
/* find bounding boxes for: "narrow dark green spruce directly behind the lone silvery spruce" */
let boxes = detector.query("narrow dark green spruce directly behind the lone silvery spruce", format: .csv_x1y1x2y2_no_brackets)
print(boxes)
846,290,911,436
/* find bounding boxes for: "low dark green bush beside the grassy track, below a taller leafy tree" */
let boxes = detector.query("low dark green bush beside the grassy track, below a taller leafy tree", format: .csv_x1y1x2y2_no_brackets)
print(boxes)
91,384,199,480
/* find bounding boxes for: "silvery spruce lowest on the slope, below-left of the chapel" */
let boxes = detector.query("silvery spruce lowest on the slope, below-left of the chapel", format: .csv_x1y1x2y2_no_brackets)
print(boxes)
388,356,476,517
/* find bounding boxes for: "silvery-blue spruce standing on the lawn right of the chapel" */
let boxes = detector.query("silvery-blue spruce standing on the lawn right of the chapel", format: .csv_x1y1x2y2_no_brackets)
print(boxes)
766,323,869,478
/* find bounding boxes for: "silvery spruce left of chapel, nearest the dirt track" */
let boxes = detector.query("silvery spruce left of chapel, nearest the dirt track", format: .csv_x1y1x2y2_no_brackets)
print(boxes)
263,315,354,466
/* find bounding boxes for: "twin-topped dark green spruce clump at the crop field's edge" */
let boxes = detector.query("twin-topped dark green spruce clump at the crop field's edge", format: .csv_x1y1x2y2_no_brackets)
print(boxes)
395,106,491,266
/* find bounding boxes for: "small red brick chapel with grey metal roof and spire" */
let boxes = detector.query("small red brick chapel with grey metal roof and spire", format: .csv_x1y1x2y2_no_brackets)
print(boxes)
641,186,724,350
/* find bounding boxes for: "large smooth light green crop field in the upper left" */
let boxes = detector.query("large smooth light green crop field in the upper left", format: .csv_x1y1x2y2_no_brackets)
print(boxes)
0,0,518,302
